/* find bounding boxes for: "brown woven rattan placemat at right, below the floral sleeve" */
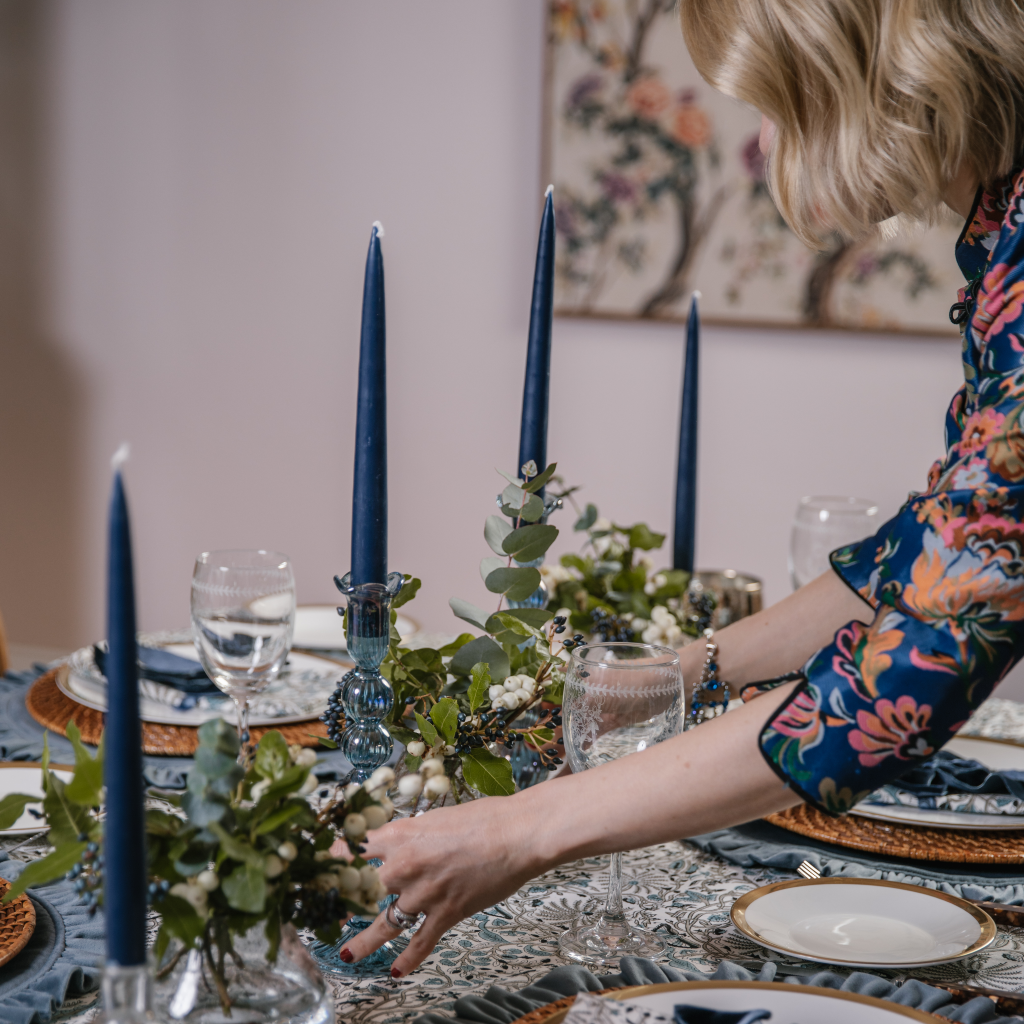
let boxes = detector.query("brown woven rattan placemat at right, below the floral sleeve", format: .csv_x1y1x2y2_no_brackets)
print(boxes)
765,804,1024,864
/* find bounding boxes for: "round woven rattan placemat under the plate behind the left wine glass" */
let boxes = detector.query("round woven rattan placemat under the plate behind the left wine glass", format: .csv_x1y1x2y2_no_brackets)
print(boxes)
25,669,327,757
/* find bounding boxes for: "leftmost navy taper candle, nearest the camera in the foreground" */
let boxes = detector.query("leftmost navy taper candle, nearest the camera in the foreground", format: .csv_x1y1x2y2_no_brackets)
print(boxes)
103,450,146,967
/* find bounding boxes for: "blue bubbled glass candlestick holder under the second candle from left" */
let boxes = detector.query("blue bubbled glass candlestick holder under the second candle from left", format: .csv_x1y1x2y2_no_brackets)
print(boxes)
322,572,402,782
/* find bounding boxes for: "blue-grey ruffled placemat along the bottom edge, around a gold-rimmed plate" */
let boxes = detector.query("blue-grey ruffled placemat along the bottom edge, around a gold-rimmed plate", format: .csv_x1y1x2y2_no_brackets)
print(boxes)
414,956,1024,1024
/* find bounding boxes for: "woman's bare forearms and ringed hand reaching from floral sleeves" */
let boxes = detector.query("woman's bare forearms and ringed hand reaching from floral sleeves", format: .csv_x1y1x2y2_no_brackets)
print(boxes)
339,572,870,975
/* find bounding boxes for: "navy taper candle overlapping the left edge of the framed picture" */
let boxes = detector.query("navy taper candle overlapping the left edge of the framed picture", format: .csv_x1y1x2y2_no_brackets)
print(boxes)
516,185,555,487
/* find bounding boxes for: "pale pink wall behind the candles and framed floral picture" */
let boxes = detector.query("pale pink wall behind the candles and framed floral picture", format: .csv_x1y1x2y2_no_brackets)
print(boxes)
8,0,1024,696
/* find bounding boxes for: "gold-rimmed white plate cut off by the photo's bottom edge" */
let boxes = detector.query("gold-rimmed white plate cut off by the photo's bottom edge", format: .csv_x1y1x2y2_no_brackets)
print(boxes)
593,981,935,1024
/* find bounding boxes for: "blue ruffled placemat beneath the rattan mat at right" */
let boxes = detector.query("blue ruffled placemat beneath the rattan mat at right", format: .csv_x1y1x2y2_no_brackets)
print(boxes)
687,821,1024,905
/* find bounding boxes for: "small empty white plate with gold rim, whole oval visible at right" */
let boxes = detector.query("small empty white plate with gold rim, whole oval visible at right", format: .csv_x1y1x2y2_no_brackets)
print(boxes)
731,879,995,968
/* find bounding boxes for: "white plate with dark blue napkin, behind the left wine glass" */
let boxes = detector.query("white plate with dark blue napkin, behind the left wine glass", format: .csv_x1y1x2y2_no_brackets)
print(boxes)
56,637,345,726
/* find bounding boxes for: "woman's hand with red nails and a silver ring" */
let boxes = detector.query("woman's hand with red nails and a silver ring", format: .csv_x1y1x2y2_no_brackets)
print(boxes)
341,782,554,978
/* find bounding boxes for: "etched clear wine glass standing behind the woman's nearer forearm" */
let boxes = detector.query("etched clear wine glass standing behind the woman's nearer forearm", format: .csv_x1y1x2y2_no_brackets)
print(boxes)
558,643,685,965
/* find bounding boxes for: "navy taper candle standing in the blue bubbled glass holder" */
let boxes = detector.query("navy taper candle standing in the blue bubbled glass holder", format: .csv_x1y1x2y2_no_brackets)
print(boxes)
352,221,387,584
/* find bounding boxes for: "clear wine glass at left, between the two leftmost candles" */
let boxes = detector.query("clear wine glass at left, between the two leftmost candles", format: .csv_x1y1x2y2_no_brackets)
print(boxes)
191,551,295,761
